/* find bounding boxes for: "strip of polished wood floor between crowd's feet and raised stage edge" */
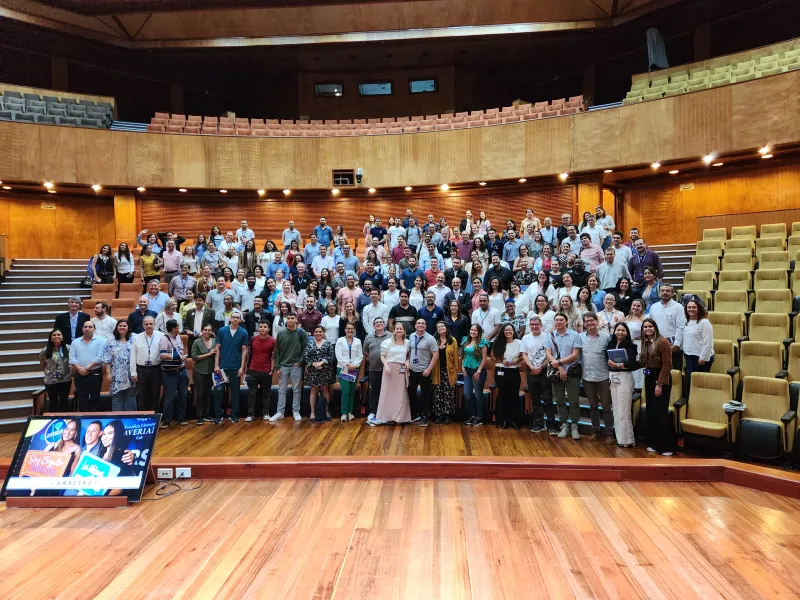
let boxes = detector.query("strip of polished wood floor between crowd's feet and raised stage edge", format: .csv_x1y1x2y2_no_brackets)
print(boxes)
0,419,661,458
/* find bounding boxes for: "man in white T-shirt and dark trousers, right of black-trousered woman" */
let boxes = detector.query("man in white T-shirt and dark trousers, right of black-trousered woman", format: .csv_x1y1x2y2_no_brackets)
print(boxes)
520,313,558,435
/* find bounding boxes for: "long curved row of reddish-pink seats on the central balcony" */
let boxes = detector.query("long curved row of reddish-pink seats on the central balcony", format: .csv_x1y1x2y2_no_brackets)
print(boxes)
147,96,586,137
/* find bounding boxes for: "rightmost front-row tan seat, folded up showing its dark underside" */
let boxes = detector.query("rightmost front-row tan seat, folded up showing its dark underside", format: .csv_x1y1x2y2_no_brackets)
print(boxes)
737,376,797,459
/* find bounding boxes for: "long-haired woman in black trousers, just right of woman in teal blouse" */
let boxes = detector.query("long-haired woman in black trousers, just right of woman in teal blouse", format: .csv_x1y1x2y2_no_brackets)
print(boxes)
492,323,522,429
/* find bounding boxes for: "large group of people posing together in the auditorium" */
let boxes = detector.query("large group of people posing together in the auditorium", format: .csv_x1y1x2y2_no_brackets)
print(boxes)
47,207,714,455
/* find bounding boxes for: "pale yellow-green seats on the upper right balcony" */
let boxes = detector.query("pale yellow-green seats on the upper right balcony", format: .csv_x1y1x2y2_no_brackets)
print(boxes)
622,45,800,105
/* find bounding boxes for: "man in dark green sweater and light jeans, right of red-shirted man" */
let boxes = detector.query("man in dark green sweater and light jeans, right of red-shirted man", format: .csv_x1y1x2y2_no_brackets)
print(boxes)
269,312,308,423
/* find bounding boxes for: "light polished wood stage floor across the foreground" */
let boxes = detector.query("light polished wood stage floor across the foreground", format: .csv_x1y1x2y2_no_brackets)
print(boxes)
0,479,800,600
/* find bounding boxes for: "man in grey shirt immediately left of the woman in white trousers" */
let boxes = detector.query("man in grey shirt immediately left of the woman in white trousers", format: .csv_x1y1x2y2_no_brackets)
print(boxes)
581,313,616,444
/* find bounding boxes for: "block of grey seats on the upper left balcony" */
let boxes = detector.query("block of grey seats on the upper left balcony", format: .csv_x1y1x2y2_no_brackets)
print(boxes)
0,90,114,129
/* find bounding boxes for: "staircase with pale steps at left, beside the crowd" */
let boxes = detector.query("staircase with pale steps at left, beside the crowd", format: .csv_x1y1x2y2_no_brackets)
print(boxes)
0,259,91,433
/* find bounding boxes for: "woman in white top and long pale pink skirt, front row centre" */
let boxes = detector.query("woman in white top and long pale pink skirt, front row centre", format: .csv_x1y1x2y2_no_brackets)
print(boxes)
367,323,411,426
